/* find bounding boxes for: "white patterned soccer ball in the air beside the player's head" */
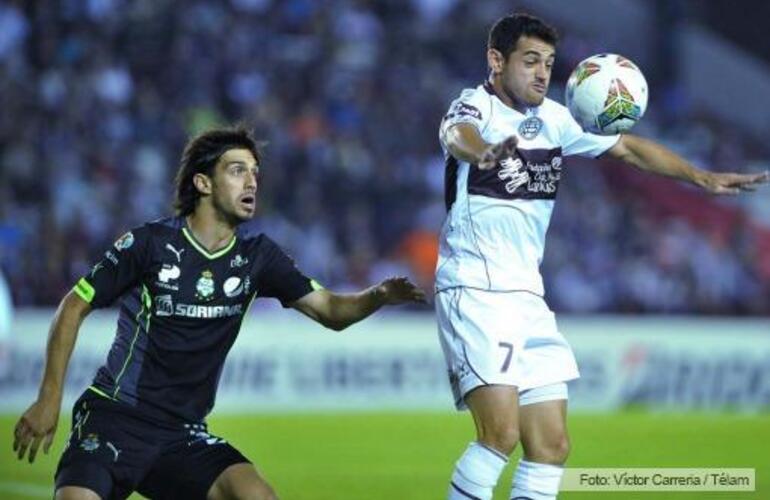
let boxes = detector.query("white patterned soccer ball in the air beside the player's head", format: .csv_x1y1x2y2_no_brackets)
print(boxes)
565,54,647,135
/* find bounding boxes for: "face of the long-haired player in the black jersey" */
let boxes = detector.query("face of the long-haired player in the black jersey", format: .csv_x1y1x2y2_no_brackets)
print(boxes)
211,149,259,224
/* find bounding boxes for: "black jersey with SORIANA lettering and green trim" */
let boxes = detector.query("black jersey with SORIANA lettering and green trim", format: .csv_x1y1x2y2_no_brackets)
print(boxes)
74,217,318,422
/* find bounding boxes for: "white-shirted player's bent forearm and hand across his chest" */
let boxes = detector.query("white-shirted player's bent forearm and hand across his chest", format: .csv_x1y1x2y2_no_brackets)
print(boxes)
444,123,518,170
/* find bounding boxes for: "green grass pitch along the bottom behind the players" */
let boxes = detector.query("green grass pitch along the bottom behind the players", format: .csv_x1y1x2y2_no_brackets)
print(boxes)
0,412,770,500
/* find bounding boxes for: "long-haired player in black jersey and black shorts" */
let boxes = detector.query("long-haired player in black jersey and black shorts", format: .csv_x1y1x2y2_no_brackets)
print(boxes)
13,128,425,500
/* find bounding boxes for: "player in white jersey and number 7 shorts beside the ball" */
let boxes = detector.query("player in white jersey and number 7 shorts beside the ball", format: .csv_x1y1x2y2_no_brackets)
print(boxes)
436,14,769,500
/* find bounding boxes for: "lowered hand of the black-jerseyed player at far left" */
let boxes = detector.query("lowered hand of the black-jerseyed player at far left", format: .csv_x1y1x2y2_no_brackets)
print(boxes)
13,399,60,463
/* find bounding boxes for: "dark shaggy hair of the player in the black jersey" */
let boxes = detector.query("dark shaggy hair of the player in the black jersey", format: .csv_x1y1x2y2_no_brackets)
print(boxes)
174,125,262,216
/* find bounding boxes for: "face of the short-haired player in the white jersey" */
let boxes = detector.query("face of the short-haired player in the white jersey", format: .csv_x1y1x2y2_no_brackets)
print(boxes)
493,36,556,106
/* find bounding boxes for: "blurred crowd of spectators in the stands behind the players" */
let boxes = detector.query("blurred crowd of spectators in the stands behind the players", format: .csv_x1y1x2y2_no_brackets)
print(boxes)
0,0,770,314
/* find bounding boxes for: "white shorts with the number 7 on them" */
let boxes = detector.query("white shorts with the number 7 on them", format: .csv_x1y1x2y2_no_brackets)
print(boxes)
436,287,580,409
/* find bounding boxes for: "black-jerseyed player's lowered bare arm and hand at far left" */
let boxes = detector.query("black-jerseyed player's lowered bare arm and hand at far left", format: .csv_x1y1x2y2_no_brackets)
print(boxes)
13,292,91,463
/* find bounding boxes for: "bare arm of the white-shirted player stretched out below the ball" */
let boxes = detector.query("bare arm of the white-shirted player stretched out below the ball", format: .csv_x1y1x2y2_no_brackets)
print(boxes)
607,134,770,194
